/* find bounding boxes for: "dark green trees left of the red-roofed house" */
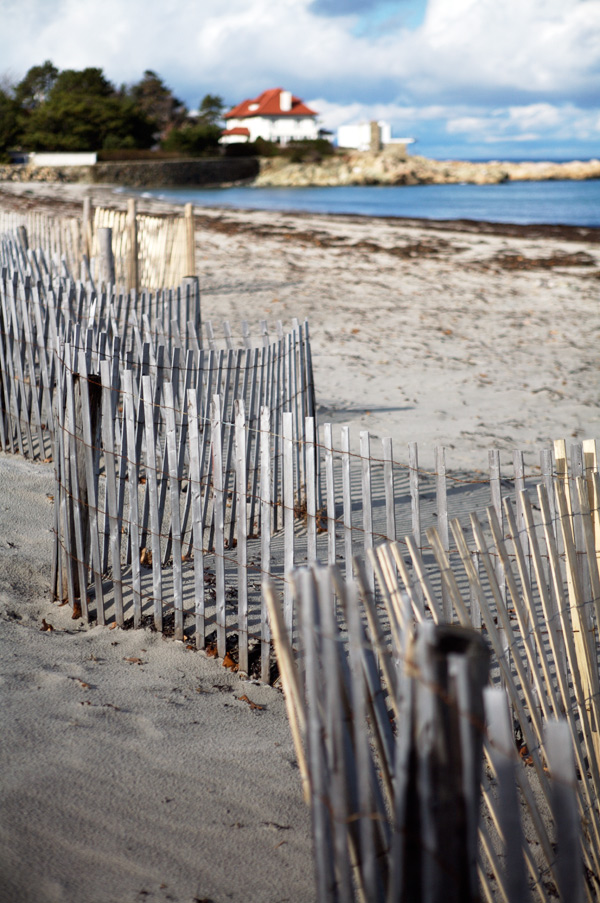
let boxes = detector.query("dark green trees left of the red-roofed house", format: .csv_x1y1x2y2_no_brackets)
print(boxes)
0,60,225,160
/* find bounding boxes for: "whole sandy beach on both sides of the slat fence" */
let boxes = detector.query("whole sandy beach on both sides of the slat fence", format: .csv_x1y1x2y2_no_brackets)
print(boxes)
0,183,600,903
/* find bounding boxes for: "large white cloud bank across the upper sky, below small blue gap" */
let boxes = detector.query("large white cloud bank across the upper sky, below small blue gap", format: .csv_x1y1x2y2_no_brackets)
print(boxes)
0,0,600,101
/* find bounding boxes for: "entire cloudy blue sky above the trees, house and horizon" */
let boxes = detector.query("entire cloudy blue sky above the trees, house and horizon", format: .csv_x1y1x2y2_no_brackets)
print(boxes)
0,0,600,159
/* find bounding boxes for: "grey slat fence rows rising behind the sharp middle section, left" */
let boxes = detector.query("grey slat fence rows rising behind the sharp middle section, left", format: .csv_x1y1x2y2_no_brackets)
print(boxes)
0,258,314,460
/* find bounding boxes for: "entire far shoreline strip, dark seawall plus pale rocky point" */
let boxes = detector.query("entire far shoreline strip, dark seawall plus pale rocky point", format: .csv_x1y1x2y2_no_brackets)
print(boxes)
0,148,600,188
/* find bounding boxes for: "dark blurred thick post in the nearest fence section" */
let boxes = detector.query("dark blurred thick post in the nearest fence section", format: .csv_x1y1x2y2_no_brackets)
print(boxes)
398,623,490,903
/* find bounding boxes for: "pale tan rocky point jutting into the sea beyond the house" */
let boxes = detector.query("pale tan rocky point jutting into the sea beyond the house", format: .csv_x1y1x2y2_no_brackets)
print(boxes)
253,148,600,188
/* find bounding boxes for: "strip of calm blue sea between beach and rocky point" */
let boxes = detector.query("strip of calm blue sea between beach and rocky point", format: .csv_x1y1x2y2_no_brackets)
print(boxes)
130,179,600,227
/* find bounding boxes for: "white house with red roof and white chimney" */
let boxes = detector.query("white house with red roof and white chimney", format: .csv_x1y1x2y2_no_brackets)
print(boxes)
221,88,319,144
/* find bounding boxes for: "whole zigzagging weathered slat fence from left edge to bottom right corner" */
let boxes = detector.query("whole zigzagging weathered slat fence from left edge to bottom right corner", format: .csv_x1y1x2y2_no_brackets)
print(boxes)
0,215,600,903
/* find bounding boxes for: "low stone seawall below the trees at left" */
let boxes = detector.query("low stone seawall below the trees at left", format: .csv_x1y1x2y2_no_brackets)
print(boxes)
0,157,260,188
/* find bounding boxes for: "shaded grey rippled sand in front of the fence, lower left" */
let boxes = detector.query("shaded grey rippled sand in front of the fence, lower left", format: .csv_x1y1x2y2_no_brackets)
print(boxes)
0,454,314,903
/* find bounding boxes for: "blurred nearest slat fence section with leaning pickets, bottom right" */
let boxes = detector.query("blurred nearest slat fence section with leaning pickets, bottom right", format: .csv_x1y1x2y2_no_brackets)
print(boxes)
265,444,600,903
